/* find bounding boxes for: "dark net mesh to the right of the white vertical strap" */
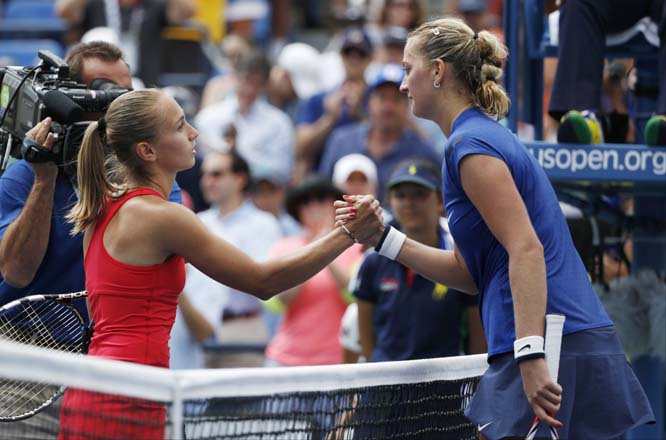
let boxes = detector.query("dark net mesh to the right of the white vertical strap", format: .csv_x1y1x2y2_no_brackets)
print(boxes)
184,378,478,440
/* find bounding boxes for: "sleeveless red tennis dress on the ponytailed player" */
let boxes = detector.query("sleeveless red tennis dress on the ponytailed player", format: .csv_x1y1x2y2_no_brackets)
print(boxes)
58,188,185,440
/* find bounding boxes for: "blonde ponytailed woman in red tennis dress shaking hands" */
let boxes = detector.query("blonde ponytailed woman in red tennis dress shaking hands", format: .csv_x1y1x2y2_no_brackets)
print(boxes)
11,90,381,439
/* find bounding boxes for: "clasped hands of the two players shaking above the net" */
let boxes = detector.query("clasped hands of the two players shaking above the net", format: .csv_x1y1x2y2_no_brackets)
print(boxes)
334,195,384,246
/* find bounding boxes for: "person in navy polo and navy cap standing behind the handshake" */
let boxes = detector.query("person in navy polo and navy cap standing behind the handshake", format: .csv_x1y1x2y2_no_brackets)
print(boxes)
352,160,485,362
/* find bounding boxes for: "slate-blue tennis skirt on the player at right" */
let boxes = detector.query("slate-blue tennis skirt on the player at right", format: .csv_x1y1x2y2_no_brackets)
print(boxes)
465,326,655,440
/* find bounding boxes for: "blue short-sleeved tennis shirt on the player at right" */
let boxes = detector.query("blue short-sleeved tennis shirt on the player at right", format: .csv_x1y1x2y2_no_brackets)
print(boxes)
442,108,612,357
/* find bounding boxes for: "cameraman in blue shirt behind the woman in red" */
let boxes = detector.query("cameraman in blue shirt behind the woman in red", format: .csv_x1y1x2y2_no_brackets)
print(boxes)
0,41,181,311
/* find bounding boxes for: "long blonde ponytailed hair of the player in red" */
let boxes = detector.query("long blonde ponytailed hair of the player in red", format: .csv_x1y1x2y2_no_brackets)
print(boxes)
67,89,164,235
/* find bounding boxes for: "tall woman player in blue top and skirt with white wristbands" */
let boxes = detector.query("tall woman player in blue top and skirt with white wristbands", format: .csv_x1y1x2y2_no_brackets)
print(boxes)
336,18,654,440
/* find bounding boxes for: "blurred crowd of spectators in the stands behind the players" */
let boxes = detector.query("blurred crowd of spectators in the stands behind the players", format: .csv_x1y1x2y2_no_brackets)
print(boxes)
0,0,660,368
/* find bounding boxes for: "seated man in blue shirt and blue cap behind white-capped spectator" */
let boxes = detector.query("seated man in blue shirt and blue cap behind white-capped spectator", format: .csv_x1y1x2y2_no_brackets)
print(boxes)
319,64,442,200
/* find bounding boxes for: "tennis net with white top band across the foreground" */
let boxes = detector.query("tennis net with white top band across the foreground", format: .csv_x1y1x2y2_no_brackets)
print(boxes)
0,341,487,440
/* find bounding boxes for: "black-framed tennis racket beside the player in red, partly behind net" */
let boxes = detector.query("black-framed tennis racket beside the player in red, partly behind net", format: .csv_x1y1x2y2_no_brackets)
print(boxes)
0,291,92,422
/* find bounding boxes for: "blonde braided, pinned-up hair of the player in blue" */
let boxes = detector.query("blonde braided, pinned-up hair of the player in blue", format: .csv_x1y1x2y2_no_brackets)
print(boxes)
409,17,510,118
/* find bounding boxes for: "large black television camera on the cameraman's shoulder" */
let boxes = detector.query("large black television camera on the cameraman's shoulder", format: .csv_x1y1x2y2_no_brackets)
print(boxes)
0,50,129,173
